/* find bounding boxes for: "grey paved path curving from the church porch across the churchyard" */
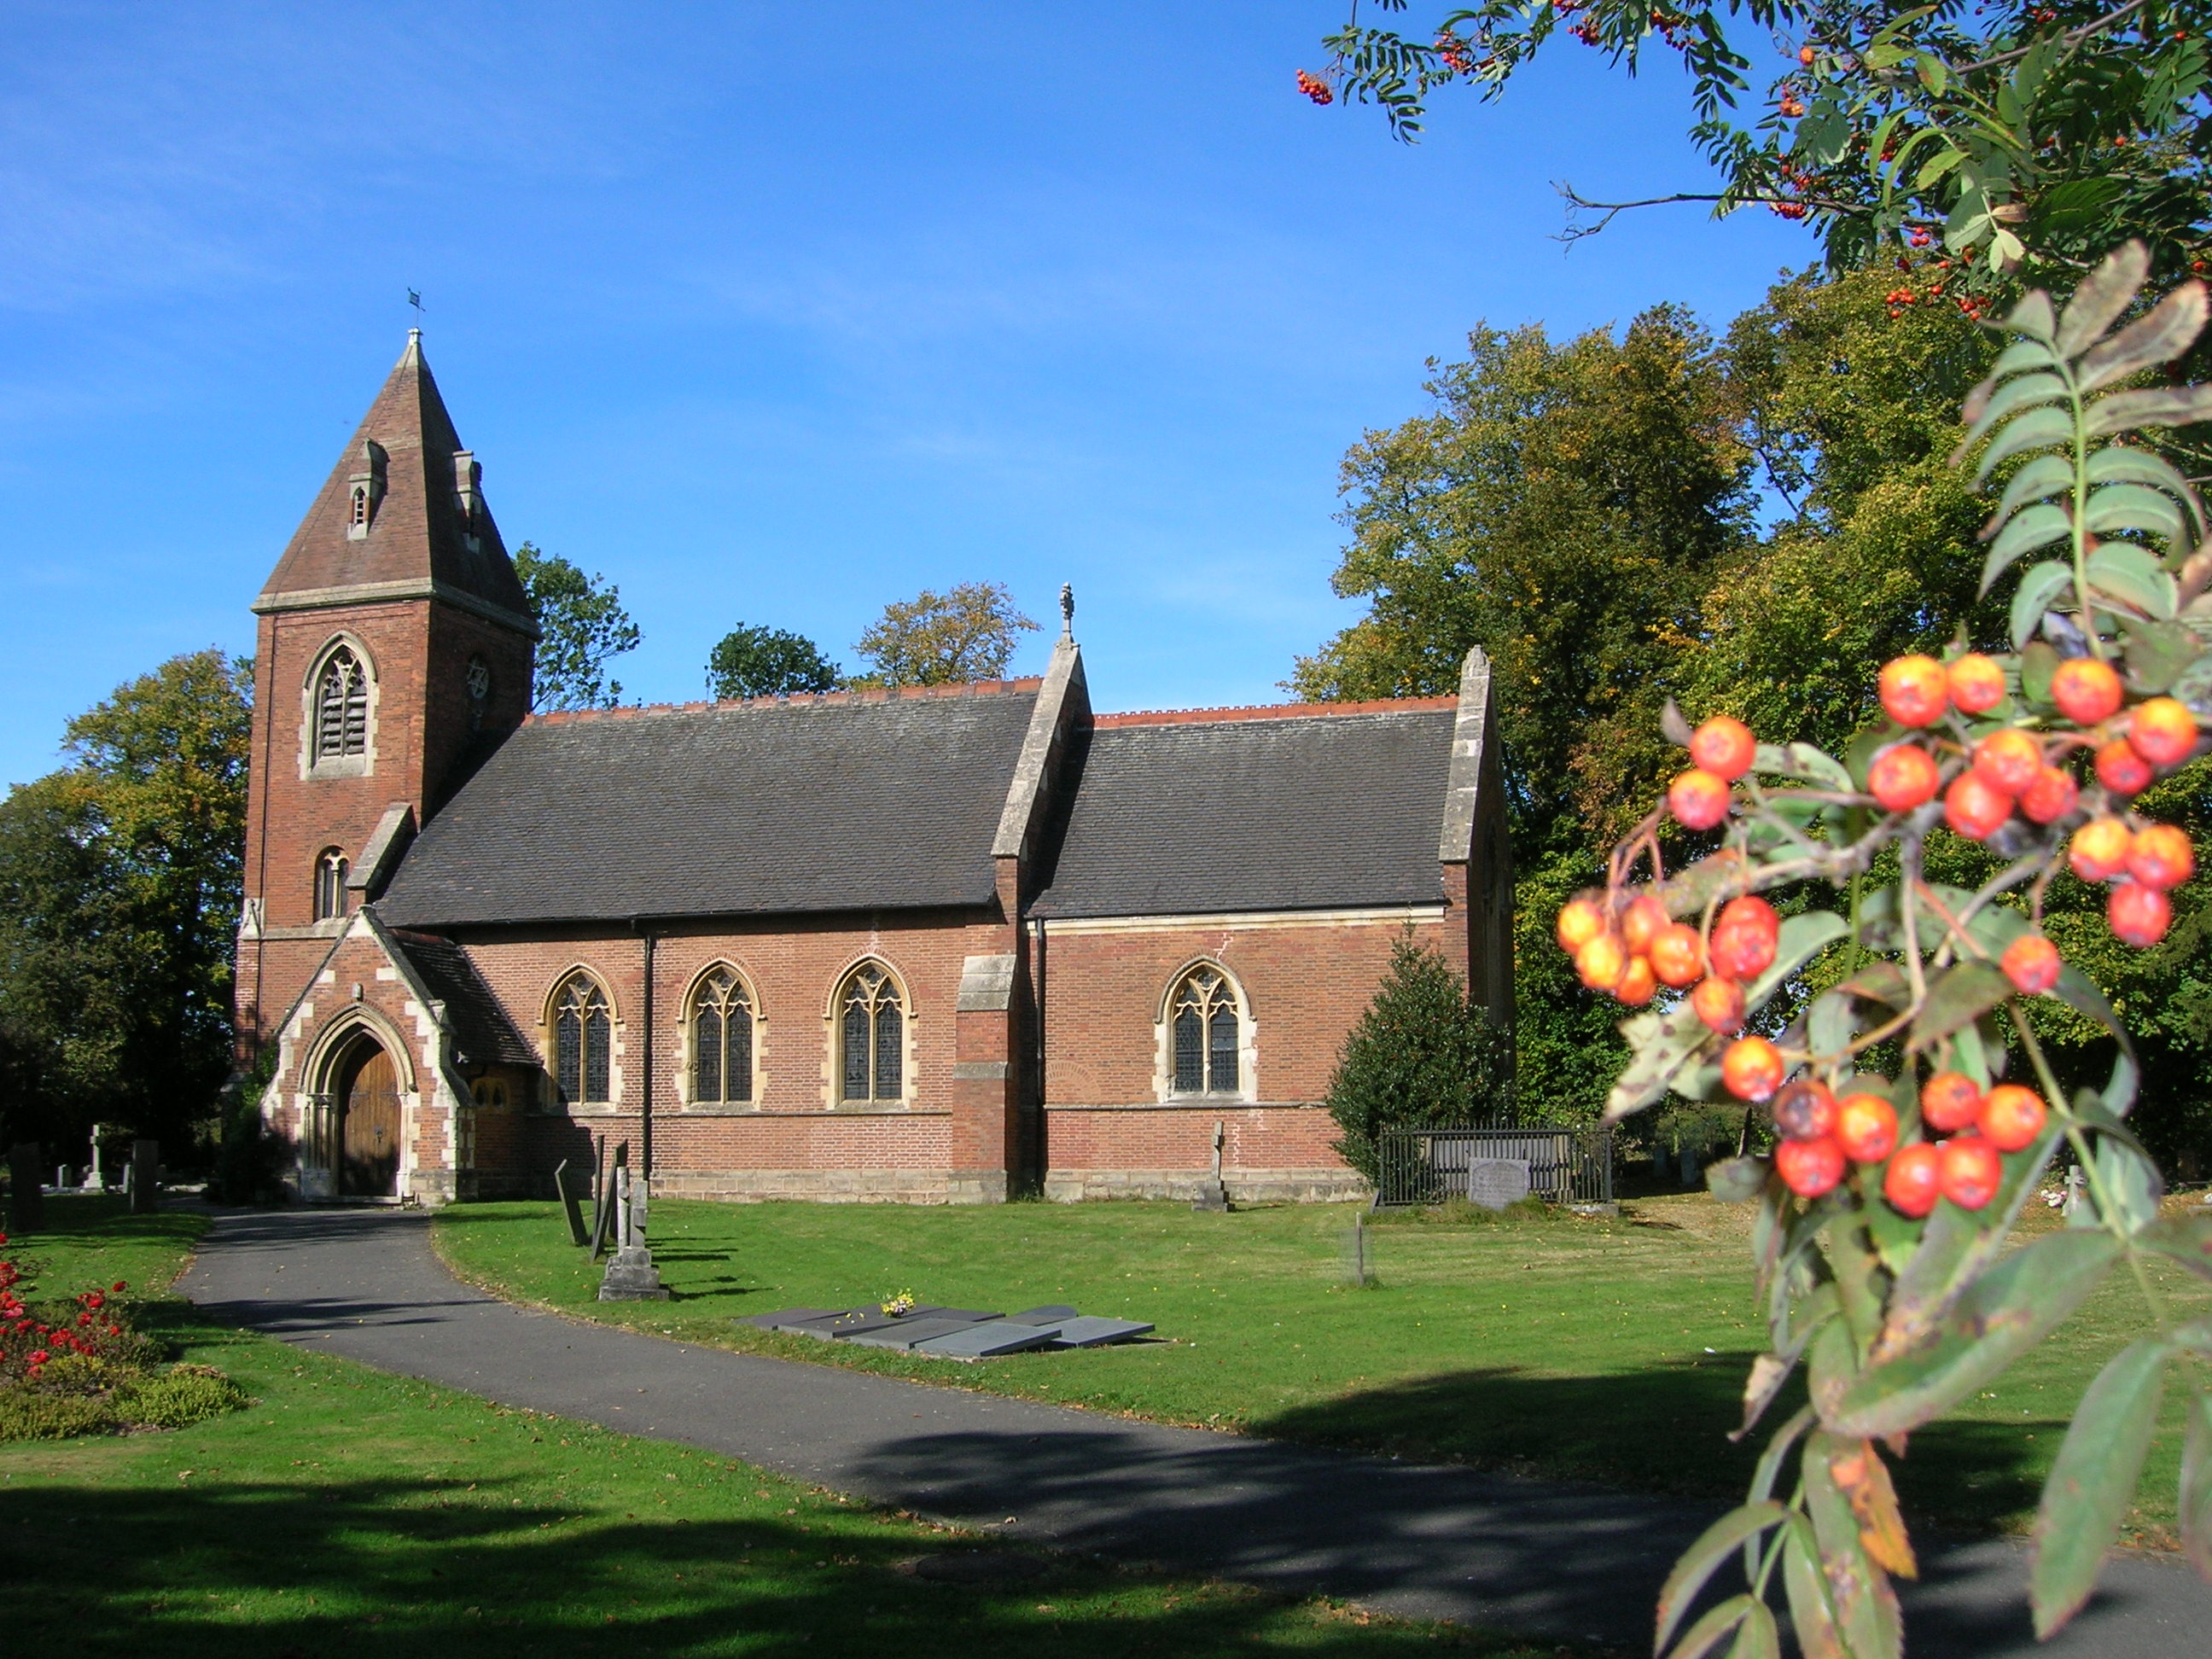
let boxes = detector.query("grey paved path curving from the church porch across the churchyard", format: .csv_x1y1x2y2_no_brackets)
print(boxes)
182,1210,2212,1659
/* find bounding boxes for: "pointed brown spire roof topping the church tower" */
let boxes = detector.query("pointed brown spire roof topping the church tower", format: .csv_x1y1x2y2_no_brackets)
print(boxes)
254,339,535,628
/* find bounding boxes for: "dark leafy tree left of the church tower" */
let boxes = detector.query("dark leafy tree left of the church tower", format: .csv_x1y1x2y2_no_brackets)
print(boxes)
0,650,252,1150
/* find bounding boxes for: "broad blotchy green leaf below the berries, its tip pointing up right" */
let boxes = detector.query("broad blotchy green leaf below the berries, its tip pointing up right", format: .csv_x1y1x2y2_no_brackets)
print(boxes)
1830,1238,2122,1440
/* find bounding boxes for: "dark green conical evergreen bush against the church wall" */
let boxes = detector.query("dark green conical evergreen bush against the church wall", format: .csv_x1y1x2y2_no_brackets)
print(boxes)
1330,929,1513,1181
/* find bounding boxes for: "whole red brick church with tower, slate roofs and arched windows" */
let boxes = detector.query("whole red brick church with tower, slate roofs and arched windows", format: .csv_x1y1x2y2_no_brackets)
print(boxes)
236,339,1513,1203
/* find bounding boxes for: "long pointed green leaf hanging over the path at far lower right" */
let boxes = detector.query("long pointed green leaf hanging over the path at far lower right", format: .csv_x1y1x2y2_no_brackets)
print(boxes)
2029,1336,2168,1641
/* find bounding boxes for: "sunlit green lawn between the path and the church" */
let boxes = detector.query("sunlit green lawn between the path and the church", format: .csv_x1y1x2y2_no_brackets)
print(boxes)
436,1195,2212,1540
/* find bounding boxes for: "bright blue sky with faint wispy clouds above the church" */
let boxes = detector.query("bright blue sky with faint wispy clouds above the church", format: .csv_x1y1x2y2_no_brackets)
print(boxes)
0,0,1812,781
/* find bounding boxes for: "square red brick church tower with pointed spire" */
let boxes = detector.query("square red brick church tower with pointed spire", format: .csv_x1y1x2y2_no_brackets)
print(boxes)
236,329,538,1064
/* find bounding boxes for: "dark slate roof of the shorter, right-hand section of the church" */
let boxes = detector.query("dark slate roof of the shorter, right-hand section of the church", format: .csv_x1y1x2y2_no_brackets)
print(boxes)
1031,703,1453,916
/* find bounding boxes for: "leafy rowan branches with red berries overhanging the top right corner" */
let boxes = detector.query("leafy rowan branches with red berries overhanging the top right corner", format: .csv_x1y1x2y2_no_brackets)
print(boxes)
1299,0,2212,296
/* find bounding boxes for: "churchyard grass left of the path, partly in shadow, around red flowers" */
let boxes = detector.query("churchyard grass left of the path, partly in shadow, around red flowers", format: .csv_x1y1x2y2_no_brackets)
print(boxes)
0,1199,1553,1659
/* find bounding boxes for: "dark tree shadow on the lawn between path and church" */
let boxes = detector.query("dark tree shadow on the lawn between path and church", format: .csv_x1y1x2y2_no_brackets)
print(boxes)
1249,1353,2066,1531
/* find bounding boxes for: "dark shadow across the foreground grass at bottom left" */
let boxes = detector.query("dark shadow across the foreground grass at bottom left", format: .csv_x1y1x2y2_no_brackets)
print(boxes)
0,1482,1528,1659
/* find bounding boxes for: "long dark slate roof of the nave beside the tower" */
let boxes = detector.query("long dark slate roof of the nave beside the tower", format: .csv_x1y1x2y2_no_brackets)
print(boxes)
376,679,1039,929
